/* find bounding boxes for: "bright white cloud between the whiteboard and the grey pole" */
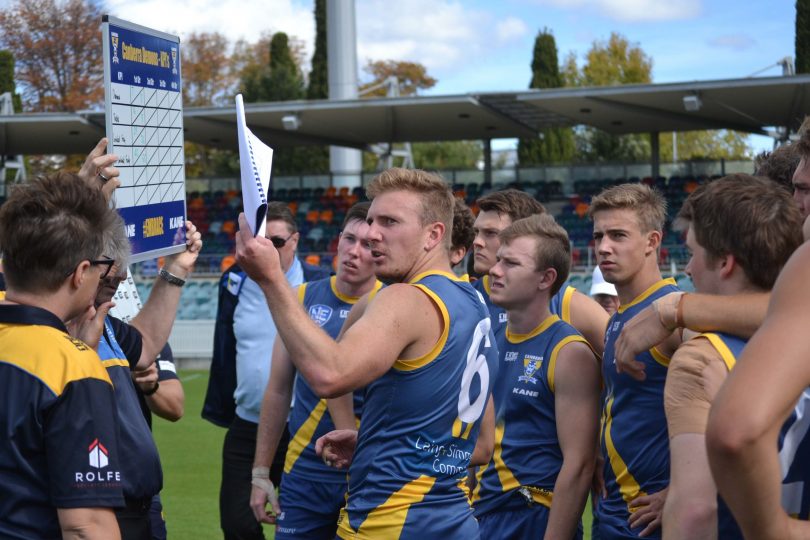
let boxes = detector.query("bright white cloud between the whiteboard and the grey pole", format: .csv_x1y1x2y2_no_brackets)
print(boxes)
107,0,315,59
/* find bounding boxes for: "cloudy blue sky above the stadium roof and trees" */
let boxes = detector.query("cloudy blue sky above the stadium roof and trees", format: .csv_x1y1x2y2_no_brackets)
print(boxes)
98,0,795,150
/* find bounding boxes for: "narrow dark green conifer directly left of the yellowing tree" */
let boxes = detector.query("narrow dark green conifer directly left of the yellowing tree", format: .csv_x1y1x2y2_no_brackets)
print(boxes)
518,28,576,166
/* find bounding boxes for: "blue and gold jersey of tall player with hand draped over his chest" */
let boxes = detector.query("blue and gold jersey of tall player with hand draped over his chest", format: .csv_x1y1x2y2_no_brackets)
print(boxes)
597,279,679,538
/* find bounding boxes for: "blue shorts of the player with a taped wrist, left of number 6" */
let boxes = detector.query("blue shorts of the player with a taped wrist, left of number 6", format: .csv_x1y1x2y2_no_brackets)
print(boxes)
276,474,346,540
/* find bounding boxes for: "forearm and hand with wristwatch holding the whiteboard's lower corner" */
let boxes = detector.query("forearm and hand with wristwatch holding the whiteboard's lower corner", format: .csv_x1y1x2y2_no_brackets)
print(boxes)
130,221,202,369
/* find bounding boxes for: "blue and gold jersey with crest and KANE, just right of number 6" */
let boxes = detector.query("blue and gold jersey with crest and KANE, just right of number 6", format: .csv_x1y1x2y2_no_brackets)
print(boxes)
472,315,598,516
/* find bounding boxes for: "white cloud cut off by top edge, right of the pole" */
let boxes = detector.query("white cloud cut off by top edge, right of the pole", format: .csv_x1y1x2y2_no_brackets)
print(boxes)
538,0,703,22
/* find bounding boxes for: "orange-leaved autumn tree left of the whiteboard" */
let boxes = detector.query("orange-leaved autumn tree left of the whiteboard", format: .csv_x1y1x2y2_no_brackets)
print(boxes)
0,0,104,111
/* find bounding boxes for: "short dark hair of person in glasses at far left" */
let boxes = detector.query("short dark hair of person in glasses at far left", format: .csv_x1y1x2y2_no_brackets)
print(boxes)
0,173,115,294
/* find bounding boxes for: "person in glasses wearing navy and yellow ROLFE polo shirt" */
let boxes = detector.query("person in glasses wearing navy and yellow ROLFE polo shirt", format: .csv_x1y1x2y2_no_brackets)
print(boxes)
0,174,125,539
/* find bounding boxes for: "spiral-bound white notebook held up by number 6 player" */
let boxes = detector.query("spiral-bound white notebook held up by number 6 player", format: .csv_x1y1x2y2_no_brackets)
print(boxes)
236,94,273,236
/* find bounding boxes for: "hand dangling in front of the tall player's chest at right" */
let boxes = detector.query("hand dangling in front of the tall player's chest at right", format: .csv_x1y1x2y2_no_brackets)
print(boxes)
614,292,682,381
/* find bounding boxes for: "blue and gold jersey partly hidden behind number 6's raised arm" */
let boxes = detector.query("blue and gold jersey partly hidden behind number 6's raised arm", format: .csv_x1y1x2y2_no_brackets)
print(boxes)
282,276,382,480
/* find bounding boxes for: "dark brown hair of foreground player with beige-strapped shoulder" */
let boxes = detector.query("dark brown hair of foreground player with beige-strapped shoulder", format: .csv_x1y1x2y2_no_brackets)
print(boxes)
676,174,802,290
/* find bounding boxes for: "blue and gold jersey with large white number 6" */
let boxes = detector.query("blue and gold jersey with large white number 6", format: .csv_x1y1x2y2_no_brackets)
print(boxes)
338,271,498,540
